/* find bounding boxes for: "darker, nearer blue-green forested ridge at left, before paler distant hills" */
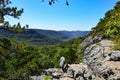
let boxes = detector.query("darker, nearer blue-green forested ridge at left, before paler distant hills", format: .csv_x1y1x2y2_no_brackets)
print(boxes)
0,29,61,45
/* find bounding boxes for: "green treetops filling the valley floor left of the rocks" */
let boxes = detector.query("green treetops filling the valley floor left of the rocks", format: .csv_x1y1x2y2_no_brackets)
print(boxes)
0,37,82,80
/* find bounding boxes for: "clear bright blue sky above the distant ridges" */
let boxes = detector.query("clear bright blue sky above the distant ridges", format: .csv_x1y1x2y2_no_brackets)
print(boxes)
6,0,119,31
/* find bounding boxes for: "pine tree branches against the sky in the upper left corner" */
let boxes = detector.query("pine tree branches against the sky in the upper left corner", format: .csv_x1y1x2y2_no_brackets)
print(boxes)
0,0,28,33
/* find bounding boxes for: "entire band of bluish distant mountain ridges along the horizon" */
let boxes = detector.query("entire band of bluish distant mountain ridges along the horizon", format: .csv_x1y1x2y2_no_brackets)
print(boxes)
0,29,89,44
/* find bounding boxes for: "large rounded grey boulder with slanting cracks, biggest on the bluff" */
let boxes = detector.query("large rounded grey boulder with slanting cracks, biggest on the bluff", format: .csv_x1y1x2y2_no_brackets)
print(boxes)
83,44,104,66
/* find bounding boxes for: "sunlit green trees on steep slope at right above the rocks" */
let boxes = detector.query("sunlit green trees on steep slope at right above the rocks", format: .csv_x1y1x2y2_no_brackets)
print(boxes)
91,1,120,49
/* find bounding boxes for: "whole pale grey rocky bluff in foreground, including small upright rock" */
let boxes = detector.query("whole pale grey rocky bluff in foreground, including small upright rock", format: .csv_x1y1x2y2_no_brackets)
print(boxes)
31,36,120,80
